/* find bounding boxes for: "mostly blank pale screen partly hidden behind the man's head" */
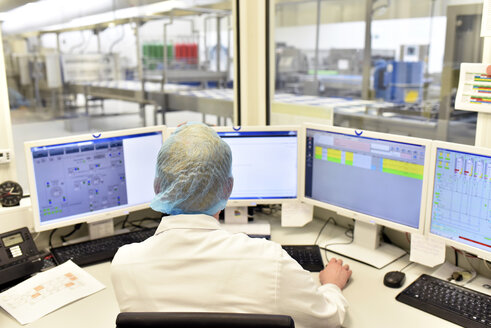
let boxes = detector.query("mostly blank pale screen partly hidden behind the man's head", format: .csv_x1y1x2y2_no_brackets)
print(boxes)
218,131,298,200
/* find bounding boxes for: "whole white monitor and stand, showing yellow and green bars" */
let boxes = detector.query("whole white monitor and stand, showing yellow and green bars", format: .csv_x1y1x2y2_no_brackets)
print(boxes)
302,124,431,268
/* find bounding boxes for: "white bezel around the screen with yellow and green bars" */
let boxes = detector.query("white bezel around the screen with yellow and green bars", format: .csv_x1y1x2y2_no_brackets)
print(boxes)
299,123,432,234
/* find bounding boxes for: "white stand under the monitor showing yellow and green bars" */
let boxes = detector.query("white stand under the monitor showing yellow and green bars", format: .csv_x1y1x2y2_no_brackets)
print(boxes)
326,221,406,269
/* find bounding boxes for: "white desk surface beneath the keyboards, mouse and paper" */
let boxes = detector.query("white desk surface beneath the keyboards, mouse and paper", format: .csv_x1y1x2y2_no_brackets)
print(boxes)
0,219,484,328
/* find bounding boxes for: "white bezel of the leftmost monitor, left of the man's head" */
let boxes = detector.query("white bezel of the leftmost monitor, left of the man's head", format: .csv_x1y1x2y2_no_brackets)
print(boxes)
24,125,166,232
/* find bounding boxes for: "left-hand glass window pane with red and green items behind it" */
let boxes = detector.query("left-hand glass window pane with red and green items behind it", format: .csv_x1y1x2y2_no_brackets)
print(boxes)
2,0,234,195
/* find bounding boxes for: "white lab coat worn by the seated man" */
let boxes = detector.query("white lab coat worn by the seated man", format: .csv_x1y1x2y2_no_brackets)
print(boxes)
111,215,348,328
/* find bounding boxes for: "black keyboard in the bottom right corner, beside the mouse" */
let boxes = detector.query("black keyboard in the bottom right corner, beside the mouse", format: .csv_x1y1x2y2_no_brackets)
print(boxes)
396,274,491,328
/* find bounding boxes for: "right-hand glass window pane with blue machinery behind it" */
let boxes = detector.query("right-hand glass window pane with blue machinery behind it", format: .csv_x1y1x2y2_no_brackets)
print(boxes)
271,0,483,144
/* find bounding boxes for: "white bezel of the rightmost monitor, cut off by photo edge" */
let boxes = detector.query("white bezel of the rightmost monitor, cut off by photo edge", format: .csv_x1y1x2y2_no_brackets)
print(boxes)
425,141,491,261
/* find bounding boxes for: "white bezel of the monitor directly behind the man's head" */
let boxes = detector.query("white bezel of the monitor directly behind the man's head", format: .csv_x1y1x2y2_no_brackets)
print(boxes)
213,125,303,207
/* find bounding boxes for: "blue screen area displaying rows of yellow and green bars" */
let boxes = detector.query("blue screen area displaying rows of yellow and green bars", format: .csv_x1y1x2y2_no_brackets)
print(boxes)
305,129,425,228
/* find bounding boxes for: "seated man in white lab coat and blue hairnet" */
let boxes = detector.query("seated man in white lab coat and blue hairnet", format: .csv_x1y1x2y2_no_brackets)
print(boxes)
111,124,351,328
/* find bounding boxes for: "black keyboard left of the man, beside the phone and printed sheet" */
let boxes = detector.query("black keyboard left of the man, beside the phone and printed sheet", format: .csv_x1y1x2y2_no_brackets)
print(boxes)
51,228,156,266
